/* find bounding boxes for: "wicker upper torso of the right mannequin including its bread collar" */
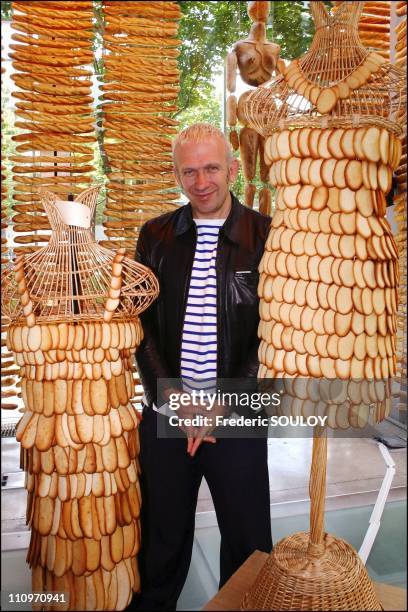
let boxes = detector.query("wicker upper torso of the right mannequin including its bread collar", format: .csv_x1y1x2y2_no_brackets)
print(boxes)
242,1,405,135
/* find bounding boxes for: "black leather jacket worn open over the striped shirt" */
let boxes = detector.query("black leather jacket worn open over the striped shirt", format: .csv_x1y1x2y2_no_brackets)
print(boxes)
136,195,270,405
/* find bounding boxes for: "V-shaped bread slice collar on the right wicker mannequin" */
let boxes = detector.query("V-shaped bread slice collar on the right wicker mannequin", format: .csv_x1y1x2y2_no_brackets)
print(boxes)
280,52,386,115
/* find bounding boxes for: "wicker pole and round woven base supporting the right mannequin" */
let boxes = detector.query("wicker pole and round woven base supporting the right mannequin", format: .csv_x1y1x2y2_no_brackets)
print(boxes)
241,427,383,611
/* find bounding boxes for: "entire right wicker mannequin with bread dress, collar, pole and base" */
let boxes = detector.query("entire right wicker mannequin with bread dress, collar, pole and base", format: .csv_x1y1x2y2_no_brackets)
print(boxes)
242,2,404,610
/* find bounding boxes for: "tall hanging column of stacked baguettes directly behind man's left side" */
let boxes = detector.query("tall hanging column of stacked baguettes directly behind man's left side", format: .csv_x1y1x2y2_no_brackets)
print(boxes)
99,2,180,257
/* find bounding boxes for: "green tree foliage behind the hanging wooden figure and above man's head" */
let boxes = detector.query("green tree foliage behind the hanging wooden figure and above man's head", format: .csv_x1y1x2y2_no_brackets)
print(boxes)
175,0,331,199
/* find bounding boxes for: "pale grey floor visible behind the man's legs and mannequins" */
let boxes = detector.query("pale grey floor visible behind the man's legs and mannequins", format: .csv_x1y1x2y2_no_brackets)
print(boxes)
2,428,406,610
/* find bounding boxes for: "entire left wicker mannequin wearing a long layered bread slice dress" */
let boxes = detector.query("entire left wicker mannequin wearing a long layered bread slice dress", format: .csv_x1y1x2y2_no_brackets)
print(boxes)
3,188,158,610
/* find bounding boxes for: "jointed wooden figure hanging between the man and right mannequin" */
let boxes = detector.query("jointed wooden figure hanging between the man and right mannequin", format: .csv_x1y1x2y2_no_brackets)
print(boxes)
227,1,280,214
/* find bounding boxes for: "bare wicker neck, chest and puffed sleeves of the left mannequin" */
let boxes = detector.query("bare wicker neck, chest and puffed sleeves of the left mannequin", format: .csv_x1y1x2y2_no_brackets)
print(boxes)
2,187,158,322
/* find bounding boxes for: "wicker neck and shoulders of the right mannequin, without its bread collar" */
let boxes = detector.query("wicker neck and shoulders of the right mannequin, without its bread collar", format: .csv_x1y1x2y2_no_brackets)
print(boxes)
243,1,406,136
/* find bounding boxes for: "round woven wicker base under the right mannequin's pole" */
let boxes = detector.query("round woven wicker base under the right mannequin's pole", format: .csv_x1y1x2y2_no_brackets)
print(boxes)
241,532,383,610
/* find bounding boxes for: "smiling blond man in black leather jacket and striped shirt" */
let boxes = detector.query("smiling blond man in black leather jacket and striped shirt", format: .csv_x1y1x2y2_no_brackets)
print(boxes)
136,124,272,610
